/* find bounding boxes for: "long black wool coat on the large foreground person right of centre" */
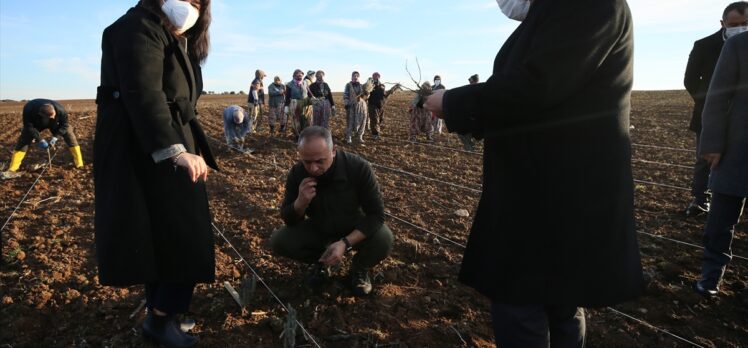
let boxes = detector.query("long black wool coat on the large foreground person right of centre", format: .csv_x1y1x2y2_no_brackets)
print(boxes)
443,0,643,307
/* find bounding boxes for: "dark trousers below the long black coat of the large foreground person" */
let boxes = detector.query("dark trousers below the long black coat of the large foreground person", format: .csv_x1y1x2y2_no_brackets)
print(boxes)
491,302,586,348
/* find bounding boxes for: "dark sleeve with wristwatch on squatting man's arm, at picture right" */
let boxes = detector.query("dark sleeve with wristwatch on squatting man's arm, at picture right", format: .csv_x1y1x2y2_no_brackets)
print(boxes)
356,162,384,238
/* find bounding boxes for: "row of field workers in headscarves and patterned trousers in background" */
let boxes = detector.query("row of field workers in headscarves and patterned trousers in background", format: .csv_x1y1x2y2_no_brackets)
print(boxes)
223,69,479,150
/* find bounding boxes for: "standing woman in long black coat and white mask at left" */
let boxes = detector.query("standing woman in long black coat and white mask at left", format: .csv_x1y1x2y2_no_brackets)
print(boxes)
94,0,217,347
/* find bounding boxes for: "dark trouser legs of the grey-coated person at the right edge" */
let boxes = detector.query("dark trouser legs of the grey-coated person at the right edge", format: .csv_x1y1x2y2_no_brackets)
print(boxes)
701,192,746,289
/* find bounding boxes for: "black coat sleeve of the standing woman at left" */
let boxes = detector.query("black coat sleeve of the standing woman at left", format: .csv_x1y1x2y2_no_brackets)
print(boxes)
112,19,182,154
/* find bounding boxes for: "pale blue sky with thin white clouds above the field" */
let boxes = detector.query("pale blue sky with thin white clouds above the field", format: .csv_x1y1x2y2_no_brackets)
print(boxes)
0,0,733,100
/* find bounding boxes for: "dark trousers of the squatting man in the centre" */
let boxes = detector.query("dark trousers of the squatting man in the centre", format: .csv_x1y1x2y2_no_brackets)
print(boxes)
270,220,394,269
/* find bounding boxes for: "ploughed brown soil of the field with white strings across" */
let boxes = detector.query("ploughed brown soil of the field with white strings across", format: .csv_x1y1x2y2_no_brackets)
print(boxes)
0,91,748,347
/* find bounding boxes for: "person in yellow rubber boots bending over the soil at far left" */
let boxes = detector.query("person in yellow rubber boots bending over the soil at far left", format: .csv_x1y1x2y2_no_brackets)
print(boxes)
8,99,83,172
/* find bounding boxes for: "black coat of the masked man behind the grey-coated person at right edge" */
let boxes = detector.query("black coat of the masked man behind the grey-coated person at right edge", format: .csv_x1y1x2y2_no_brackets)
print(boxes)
683,30,725,134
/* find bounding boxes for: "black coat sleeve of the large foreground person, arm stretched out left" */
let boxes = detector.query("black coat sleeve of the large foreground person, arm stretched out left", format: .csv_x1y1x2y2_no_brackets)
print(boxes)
443,1,633,134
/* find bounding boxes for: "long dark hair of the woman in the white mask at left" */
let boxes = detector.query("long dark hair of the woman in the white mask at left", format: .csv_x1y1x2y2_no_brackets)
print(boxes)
140,0,212,64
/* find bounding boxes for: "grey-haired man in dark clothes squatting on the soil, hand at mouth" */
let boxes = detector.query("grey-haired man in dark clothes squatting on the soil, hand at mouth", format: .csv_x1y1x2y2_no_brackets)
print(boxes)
270,126,393,296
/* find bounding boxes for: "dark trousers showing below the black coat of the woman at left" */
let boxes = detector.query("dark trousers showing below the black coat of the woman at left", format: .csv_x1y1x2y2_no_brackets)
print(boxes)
145,283,195,315
